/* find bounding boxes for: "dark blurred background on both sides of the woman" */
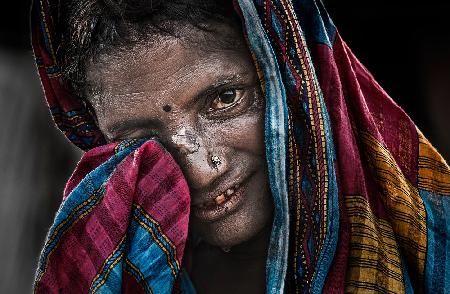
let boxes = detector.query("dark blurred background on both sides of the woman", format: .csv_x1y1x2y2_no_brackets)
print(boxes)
0,0,450,293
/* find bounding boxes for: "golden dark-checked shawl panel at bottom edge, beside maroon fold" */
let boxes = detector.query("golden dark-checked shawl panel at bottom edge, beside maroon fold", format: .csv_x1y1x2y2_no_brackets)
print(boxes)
344,195,405,293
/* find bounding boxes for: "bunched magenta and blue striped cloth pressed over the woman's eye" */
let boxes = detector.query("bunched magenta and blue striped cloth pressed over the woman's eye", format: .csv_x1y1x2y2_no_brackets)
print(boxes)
35,139,190,293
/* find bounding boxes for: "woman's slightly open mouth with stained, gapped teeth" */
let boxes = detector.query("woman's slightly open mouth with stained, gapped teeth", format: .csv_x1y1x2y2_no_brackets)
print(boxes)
191,177,250,222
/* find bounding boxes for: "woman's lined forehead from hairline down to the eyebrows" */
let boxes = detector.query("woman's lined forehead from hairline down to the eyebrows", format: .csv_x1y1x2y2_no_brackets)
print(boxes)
87,26,254,111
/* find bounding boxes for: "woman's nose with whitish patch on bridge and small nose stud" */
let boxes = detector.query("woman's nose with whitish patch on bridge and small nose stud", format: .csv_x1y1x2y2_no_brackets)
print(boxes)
169,127,227,190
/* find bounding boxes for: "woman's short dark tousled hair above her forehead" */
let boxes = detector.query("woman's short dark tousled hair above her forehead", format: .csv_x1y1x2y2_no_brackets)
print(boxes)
56,0,240,98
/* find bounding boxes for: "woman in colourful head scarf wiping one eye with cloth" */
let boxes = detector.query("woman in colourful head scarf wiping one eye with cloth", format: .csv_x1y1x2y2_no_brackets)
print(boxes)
32,0,450,293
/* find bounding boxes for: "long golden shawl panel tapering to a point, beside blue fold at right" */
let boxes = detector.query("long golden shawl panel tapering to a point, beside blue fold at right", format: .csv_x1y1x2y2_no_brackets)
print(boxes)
361,132,427,284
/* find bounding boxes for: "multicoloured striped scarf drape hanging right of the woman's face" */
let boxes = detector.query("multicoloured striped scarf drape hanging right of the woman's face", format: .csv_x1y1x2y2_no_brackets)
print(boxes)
237,0,450,293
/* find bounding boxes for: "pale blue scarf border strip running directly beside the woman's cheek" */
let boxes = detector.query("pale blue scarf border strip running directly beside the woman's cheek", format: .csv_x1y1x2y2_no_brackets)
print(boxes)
239,0,289,293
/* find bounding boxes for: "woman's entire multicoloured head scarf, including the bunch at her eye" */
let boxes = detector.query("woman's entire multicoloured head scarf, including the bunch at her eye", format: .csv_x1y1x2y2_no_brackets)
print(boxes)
32,0,450,293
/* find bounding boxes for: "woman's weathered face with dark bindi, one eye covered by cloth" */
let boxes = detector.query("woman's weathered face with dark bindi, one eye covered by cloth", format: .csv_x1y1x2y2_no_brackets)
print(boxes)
88,26,273,247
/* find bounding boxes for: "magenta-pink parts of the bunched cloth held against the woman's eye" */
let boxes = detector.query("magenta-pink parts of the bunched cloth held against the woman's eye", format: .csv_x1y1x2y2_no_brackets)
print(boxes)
36,141,190,293
